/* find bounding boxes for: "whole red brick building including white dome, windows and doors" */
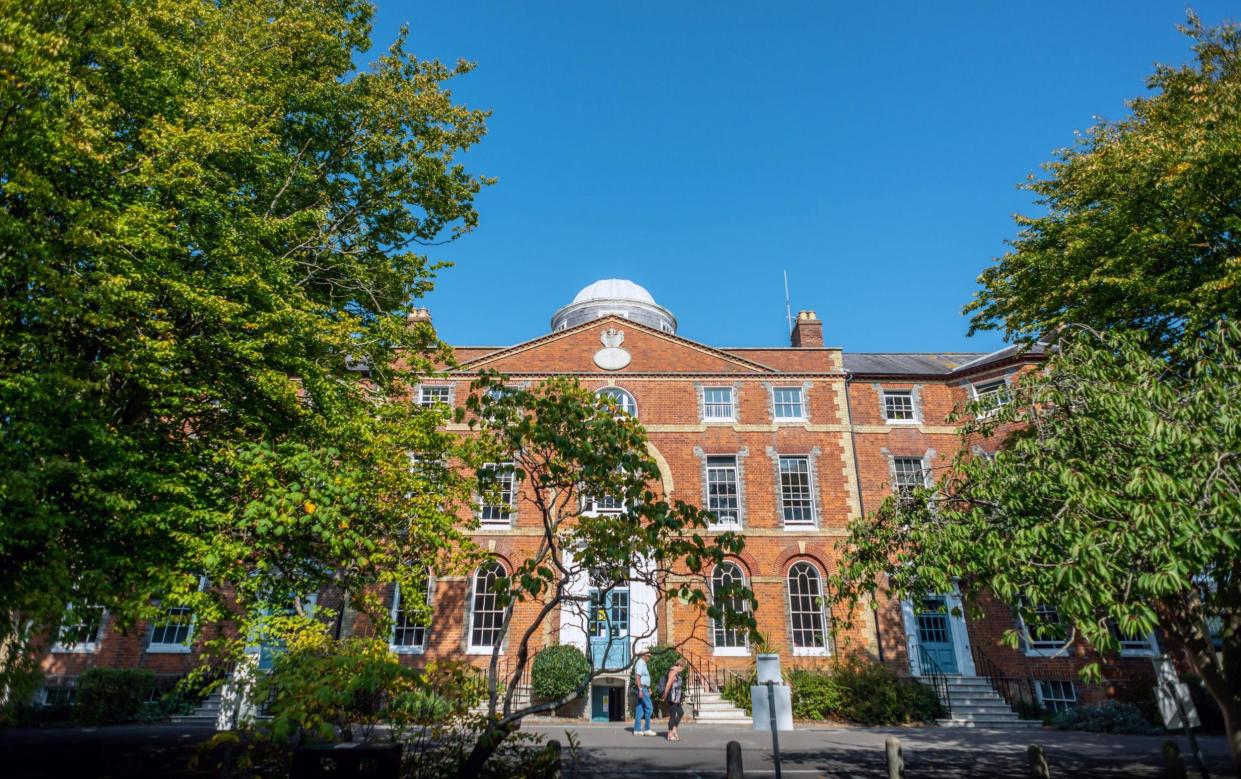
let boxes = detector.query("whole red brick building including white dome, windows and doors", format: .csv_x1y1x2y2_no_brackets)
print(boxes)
43,279,1155,708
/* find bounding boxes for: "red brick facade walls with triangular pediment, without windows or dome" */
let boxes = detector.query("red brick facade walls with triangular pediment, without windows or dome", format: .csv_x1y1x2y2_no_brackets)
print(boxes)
43,282,1150,714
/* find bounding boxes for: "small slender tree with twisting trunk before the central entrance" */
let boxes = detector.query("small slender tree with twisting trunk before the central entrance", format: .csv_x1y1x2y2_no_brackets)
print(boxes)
458,373,755,777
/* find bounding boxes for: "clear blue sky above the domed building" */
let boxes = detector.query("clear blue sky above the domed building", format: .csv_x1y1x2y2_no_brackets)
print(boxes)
362,0,1241,351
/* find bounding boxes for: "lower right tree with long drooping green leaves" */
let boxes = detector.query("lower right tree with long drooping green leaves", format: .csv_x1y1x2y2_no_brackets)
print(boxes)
836,323,1241,768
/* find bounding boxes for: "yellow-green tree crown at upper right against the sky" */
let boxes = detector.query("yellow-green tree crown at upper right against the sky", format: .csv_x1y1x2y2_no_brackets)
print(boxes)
965,14,1241,350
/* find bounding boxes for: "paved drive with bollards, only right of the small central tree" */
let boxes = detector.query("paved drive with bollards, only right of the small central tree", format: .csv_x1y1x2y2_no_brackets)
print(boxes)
526,723,1231,779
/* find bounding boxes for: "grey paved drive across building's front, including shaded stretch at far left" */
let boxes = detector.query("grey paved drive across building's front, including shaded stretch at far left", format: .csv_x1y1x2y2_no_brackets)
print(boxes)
0,722,1231,779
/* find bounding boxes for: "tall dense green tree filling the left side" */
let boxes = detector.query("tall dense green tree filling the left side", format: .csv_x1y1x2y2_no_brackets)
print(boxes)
0,0,488,704
